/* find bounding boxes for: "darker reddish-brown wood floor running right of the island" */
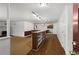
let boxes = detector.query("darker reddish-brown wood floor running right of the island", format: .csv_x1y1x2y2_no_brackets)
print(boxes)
28,34,65,55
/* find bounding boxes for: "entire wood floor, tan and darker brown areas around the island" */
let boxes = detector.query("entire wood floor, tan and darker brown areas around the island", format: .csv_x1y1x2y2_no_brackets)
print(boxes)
11,34,65,55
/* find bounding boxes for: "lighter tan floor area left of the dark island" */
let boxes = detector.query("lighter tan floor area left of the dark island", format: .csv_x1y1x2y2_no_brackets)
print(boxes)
10,36,32,55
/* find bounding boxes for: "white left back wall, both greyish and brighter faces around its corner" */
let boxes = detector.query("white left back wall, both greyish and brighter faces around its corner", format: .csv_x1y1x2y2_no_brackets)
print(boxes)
10,21,34,37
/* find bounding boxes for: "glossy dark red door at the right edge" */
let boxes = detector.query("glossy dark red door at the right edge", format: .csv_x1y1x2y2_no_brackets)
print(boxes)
73,4,79,52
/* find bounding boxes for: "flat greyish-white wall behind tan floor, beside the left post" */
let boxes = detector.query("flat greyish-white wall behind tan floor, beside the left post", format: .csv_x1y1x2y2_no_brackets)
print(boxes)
10,21,24,36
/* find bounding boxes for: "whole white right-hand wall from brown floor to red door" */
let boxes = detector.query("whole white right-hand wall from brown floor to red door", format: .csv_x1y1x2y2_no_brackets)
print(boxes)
57,4,73,54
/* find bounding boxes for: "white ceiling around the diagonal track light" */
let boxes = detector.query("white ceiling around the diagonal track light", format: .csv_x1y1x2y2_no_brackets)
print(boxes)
10,3,65,22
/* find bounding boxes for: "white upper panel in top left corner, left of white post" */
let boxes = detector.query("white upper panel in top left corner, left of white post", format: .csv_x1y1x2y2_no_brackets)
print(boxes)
0,3,8,20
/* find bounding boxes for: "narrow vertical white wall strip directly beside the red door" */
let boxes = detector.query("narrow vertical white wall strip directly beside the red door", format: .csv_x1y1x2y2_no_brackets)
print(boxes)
67,4,73,54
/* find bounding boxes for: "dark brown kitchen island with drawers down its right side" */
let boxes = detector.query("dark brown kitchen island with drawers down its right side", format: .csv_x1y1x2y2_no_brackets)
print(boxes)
32,31,46,50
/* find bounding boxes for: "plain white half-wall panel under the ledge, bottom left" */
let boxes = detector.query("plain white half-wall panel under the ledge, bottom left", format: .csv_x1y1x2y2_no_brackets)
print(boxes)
0,38,10,55
